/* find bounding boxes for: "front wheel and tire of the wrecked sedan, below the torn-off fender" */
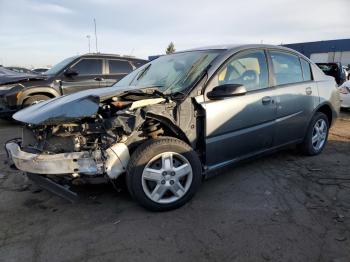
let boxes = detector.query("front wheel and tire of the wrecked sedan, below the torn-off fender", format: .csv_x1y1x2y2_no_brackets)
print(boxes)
126,137,202,211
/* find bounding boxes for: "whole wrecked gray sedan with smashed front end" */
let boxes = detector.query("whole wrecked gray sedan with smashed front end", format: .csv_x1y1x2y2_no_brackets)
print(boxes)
6,45,339,211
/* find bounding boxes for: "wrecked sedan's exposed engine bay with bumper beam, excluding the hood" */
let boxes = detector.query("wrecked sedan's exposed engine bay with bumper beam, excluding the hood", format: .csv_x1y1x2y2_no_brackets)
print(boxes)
8,88,204,186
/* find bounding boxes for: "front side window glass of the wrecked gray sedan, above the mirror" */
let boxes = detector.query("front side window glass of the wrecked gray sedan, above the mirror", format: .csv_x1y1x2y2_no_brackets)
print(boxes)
218,50,269,91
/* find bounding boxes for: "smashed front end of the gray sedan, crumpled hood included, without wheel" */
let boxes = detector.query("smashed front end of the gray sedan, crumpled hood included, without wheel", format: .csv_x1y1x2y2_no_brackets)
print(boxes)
6,88,201,201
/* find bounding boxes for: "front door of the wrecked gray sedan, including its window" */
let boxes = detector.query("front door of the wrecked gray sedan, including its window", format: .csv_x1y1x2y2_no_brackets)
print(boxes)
204,50,276,169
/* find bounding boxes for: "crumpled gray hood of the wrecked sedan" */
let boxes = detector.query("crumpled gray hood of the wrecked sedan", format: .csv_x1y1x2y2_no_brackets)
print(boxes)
13,87,161,125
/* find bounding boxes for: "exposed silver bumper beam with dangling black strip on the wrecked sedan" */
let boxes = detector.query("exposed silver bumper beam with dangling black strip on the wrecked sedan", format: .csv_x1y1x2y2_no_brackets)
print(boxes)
6,141,130,203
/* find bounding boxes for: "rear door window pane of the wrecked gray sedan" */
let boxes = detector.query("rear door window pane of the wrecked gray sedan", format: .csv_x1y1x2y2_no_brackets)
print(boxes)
270,51,303,85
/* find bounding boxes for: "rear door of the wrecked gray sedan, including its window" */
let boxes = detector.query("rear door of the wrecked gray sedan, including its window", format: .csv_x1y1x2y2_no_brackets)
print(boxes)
269,50,318,146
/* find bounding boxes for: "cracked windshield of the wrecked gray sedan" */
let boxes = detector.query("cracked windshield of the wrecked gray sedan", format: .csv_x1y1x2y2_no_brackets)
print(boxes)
114,50,220,94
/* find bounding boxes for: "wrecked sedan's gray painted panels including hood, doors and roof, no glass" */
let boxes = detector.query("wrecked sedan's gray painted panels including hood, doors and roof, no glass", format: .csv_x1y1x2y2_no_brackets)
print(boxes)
14,45,340,176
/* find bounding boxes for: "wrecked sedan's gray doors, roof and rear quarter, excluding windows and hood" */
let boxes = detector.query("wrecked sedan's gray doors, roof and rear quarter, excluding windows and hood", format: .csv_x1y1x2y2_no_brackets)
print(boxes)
191,45,340,170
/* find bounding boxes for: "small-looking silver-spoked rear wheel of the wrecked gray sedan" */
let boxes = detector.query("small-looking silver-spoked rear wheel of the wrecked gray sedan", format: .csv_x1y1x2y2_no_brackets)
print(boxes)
300,112,329,156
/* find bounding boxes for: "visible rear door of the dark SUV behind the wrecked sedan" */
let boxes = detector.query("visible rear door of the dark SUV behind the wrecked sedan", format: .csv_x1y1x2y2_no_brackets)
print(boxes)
104,59,134,86
